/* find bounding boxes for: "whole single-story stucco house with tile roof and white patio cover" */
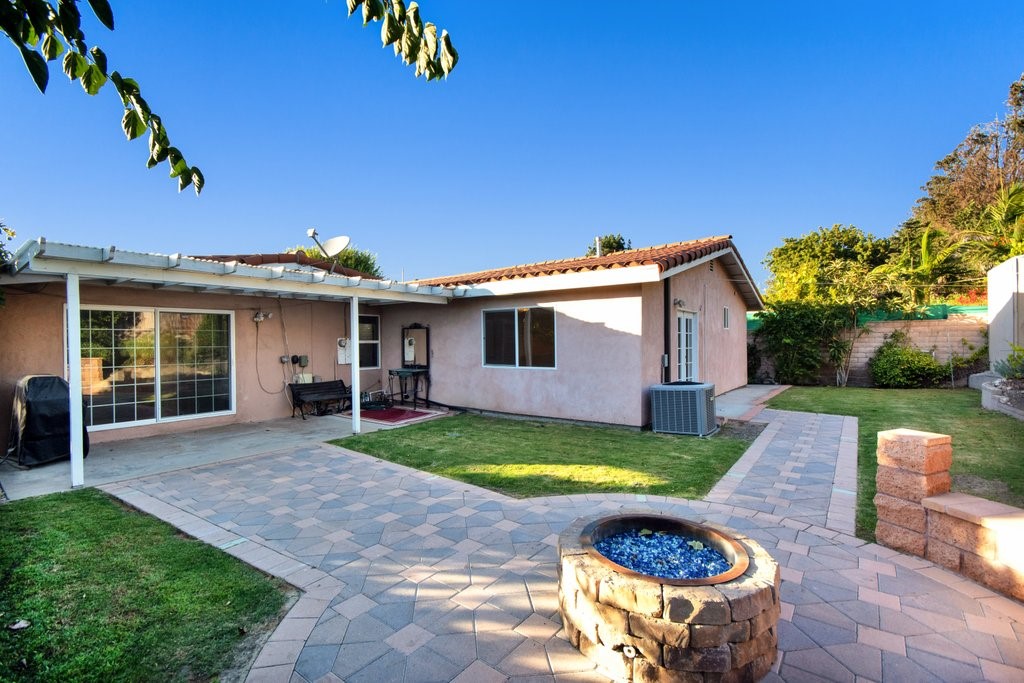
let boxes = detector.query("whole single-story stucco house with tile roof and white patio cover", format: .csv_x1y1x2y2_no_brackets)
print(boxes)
0,236,762,479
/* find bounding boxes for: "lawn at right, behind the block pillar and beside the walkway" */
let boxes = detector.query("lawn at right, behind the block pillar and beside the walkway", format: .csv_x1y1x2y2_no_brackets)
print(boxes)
768,387,1024,540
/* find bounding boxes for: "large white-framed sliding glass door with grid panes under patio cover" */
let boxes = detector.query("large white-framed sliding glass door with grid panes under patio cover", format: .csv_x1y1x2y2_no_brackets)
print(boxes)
73,306,234,429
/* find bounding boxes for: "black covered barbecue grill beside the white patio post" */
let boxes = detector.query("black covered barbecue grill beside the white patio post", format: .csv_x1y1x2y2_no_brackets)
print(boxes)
7,375,89,467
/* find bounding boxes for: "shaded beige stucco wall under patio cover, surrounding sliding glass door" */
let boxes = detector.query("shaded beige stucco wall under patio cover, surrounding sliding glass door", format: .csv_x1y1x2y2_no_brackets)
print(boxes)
0,284,381,447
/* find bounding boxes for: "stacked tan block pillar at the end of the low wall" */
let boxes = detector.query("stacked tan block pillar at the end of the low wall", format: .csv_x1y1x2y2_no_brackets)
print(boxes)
874,429,953,557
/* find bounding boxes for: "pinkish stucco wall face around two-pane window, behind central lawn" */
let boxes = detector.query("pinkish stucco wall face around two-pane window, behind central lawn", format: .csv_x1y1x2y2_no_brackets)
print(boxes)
382,287,642,425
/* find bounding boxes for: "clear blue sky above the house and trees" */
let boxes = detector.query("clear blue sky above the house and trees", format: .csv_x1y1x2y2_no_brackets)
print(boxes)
0,0,1024,284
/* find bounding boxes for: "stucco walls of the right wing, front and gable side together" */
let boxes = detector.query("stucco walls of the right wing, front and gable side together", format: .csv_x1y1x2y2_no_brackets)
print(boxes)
382,264,746,426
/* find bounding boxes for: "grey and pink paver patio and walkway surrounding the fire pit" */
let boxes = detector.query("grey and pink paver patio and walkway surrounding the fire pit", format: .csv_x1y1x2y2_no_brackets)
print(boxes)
97,411,1024,683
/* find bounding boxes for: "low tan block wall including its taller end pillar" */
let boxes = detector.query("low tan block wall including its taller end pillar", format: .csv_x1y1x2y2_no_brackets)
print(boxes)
874,429,1024,600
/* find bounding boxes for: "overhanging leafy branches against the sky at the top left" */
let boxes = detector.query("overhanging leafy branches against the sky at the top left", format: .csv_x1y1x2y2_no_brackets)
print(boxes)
0,0,459,195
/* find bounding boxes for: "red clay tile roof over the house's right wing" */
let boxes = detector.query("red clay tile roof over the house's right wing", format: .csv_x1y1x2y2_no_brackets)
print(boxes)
416,234,732,287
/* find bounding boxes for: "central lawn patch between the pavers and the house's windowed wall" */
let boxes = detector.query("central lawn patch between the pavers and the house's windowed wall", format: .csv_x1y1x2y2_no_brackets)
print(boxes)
332,415,753,499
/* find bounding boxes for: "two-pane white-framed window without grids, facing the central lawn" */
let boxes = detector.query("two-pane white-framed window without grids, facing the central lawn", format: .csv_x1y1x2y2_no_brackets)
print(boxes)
482,306,555,368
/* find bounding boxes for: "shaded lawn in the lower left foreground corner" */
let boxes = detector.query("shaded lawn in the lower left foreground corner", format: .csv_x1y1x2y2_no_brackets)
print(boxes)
0,489,287,681
